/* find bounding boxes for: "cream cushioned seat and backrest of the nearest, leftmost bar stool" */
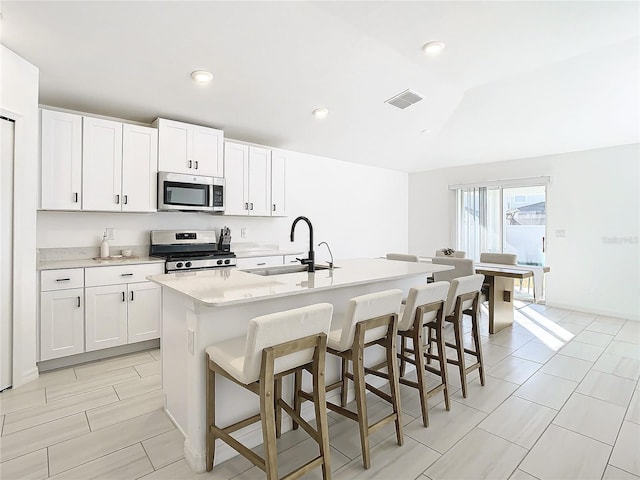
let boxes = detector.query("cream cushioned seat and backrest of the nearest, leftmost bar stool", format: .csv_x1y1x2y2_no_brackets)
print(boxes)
206,303,333,385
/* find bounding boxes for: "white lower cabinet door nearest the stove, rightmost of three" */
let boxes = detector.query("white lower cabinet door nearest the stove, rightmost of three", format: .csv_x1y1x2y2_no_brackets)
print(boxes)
127,282,161,343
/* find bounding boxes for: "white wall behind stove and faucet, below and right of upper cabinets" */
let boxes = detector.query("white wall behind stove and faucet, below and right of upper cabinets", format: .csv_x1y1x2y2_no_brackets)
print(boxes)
37,152,408,261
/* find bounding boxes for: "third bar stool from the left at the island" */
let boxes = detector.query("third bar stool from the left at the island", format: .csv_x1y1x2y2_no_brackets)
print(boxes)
392,282,451,427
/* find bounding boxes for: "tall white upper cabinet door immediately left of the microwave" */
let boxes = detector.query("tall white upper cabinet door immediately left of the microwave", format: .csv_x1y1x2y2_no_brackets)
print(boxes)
122,124,158,212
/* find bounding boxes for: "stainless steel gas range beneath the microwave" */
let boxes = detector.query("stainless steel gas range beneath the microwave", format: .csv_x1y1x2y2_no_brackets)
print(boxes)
149,227,236,273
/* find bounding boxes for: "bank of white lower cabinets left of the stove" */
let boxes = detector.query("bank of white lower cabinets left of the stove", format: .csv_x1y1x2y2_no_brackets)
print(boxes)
40,263,164,361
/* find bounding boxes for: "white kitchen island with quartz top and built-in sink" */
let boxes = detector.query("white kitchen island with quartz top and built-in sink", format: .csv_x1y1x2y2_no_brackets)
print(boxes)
148,258,453,472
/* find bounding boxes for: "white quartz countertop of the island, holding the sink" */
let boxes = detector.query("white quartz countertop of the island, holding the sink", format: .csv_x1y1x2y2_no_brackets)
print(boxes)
147,258,453,307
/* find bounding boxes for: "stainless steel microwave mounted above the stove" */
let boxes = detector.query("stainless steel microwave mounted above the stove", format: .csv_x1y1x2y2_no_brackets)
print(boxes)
158,172,224,213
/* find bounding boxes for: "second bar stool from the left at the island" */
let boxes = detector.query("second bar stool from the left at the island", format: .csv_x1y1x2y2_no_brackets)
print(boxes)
301,289,403,468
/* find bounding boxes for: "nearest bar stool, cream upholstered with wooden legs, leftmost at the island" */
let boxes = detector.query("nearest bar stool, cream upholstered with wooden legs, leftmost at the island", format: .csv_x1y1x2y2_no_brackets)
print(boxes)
206,303,333,480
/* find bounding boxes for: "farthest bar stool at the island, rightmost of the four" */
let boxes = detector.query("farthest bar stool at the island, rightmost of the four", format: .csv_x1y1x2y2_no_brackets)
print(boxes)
427,274,484,398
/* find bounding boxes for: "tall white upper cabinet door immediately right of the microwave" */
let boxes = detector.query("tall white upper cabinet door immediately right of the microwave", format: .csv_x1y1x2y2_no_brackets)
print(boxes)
224,142,249,215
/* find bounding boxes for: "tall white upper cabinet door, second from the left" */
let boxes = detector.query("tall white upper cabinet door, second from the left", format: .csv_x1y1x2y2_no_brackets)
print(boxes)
82,117,122,212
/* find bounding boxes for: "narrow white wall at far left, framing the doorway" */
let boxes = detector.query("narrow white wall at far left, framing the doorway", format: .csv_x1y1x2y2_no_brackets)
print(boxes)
0,45,38,387
